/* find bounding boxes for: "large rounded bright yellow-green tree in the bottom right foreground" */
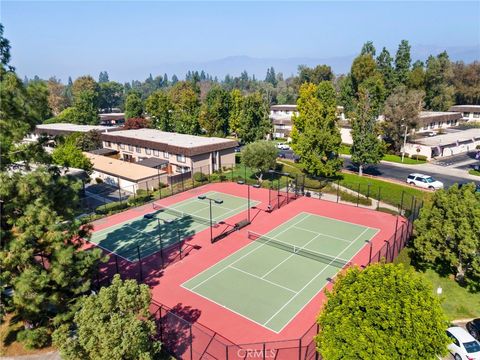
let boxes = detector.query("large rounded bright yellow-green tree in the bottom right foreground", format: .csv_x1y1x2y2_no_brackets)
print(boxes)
315,264,449,360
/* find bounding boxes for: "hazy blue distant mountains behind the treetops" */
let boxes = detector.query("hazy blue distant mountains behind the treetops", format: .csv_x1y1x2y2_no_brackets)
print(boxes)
148,45,480,79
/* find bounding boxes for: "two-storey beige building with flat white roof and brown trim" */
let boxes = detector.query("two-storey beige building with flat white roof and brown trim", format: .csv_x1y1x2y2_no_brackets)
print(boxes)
101,129,237,174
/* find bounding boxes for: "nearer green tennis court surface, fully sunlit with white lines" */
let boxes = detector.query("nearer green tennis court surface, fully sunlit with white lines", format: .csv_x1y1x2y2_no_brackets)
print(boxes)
182,213,378,333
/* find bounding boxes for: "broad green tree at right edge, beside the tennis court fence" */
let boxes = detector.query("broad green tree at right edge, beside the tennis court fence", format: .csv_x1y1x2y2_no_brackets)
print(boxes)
413,183,480,292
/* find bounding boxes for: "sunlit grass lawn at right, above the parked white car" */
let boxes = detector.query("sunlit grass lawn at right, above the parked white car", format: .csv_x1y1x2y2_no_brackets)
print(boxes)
395,248,480,320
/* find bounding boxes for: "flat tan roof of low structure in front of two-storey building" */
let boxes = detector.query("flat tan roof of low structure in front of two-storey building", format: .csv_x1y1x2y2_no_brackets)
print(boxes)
84,152,165,182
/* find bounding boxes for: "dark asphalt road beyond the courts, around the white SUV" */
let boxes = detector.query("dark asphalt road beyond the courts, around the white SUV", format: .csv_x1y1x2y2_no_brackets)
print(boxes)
344,159,478,187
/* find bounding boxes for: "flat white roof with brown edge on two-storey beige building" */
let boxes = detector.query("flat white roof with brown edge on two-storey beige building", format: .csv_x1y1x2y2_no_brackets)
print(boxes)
102,129,238,156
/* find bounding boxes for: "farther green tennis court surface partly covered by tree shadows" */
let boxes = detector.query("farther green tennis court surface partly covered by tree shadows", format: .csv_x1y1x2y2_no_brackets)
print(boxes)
90,191,258,262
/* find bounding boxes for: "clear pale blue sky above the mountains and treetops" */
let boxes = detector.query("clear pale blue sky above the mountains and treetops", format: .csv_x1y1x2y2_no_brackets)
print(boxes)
0,0,480,81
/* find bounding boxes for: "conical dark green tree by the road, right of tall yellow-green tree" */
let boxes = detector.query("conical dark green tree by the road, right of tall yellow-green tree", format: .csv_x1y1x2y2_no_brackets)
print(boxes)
351,91,385,176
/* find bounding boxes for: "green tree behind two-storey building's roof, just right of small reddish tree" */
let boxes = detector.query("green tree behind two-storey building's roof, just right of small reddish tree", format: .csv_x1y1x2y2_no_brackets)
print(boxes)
145,90,174,131
